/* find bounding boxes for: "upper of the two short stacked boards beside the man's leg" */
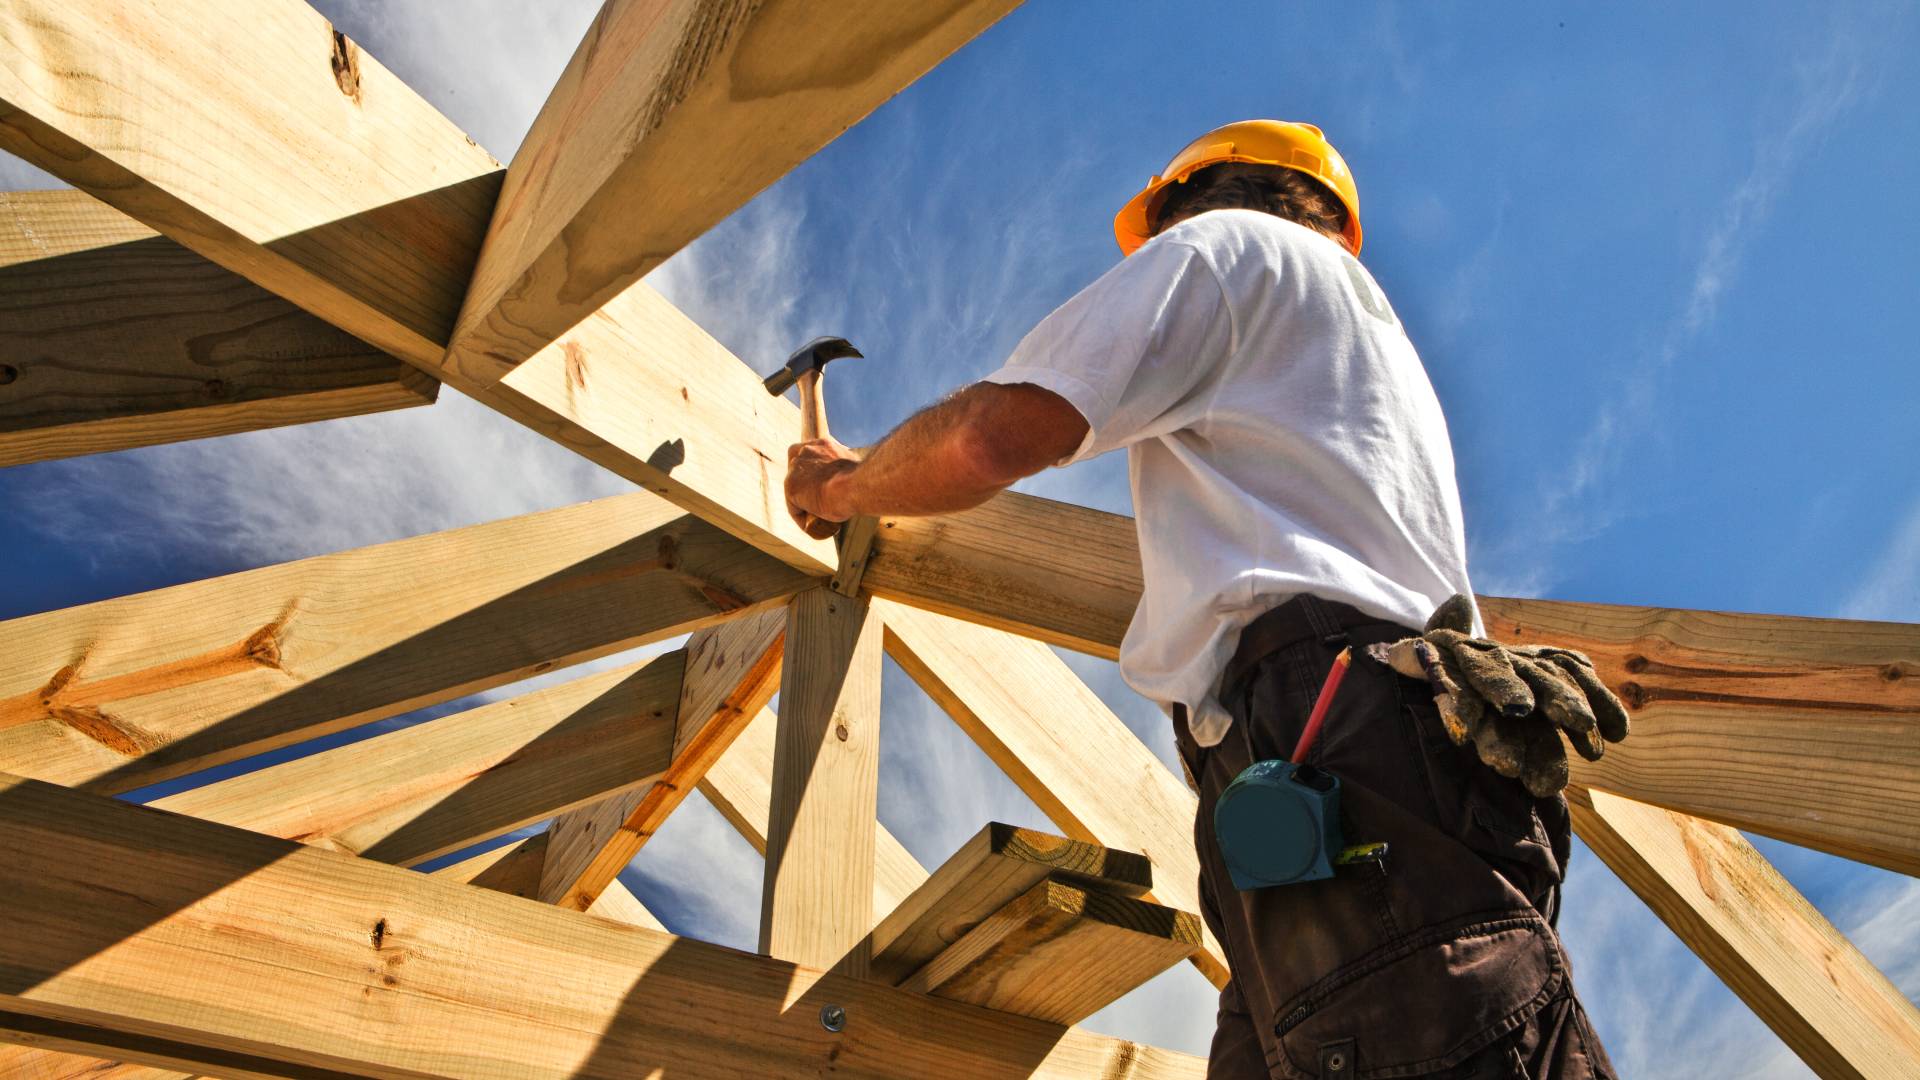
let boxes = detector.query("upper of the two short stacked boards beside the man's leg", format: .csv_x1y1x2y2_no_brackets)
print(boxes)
868,821,1154,990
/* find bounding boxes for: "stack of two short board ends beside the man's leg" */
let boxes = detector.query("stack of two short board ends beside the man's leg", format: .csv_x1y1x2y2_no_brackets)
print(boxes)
868,822,1200,1024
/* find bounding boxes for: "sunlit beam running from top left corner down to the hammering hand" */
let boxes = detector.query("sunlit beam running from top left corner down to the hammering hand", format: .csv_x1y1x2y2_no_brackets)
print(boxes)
0,0,840,575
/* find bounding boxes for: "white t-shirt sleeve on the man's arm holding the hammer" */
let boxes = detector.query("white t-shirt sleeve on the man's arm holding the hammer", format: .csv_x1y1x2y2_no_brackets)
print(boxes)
985,236,1233,465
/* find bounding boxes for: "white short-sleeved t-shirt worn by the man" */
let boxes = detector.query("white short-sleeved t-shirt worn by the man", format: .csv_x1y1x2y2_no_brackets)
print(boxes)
987,209,1473,746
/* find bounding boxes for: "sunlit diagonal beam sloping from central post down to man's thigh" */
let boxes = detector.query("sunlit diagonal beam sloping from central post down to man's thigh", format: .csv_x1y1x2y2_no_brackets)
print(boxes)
876,600,1229,986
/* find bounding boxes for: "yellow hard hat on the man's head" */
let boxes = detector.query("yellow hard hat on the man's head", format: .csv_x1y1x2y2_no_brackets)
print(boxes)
1114,119,1359,256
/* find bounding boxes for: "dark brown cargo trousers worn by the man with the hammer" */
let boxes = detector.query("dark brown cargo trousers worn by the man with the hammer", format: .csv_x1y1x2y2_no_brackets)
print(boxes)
1173,596,1615,1080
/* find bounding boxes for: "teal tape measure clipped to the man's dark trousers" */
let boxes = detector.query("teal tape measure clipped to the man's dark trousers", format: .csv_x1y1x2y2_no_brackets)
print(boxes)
1213,759,1342,892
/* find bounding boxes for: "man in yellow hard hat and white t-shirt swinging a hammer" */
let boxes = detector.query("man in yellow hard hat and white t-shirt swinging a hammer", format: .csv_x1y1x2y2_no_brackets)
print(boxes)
787,119,1626,1078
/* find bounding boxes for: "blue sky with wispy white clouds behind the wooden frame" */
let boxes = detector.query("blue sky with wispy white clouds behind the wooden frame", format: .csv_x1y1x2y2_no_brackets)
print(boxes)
0,0,1920,1076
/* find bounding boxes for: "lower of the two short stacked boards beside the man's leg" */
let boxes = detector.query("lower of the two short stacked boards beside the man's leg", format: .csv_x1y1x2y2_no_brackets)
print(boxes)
900,878,1200,1024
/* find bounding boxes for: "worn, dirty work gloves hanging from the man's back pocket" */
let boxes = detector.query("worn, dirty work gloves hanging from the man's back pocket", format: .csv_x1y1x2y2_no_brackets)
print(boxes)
1367,594,1628,798
